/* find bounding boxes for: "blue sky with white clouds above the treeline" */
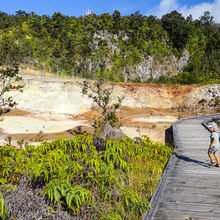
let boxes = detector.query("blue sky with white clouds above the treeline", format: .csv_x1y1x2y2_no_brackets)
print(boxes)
0,0,220,23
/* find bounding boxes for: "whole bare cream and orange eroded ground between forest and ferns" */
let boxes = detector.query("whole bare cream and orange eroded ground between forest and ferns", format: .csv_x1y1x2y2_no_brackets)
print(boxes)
0,75,220,146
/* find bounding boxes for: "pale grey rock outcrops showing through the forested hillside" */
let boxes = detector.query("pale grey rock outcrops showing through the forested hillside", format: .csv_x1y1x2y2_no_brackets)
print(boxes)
92,30,190,82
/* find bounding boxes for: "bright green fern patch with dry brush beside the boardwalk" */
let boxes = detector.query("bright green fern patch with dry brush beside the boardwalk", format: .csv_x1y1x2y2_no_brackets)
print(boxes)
0,135,172,219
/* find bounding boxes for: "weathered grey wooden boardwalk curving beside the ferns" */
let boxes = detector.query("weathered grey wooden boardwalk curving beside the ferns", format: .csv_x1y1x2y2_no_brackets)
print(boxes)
143,115,220,220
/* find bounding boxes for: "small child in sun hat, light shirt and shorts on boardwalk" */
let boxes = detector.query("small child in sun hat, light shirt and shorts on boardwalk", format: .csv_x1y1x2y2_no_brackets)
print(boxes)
208,123,220,167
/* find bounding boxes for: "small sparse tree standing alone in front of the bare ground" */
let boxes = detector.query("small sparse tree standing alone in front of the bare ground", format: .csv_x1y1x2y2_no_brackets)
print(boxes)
81,80,125,129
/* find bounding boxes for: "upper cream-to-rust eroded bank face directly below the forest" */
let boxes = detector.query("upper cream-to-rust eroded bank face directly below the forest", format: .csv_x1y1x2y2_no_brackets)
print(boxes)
5,75,220,117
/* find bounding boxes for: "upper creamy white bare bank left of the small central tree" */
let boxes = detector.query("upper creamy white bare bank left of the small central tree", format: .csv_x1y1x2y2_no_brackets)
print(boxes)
4,75,92,119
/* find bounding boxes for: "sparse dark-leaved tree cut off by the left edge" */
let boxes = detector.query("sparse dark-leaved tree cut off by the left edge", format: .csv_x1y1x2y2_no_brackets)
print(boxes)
0,65,22,115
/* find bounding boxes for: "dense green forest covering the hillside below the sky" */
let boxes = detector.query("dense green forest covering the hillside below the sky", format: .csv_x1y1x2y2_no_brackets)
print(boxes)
0,10,220,84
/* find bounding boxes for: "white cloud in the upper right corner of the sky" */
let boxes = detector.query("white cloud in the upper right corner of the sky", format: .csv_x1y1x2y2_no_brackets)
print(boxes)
148,0,220,23
